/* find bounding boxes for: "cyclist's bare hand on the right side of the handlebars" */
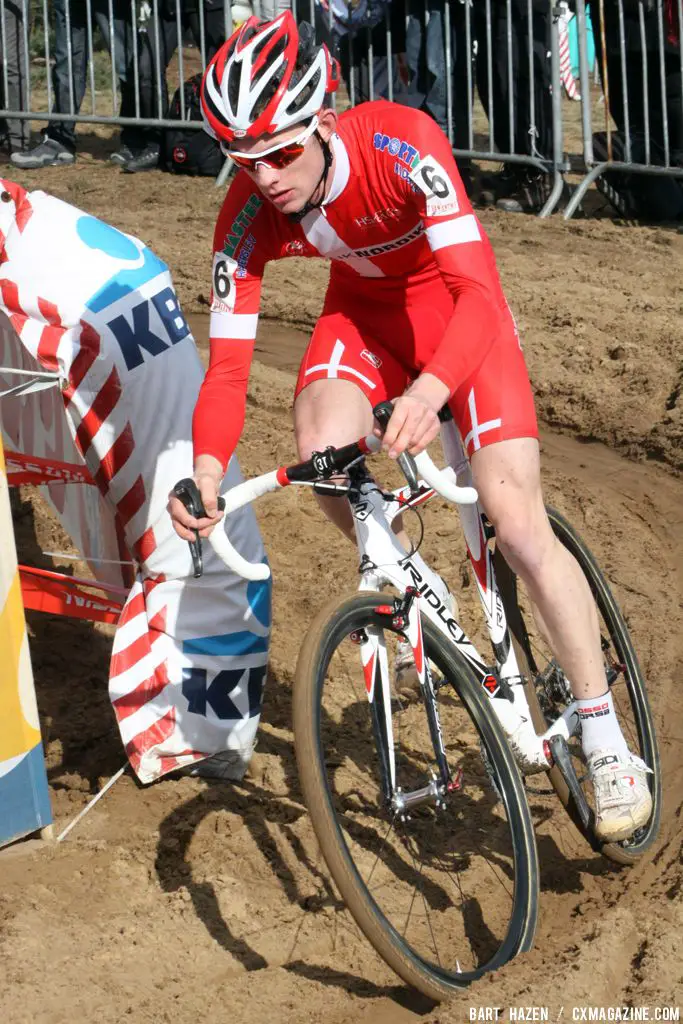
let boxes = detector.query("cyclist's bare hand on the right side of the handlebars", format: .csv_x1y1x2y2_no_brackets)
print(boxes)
377,374,450,459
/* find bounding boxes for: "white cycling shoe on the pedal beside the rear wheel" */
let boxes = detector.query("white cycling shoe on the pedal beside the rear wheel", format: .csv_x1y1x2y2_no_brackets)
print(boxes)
588,749,652,843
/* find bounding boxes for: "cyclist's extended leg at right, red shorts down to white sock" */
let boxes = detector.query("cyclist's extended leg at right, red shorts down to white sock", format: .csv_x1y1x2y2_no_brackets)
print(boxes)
451,318,605,697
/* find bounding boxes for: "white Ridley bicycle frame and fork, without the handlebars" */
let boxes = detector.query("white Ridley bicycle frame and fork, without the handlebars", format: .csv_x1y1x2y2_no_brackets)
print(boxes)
348,422,579,778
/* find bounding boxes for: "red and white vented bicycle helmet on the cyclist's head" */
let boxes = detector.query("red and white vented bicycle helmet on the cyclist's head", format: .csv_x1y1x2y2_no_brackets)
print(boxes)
201,10,339,142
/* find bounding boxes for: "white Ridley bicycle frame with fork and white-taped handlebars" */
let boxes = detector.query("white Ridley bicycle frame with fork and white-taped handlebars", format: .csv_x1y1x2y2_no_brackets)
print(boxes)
193,422,579,782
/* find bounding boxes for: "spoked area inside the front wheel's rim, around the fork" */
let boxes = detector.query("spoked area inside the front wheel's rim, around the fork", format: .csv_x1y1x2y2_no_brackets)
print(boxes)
323,614,514,973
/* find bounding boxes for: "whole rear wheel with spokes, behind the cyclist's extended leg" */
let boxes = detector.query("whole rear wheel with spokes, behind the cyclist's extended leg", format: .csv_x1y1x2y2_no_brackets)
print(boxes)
496,508,661,864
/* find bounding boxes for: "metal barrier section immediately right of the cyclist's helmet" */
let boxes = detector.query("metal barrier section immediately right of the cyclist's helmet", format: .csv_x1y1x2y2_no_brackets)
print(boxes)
331,0,564,216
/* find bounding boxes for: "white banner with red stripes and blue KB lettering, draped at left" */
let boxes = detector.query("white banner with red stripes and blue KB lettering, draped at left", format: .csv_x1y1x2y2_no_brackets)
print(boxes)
0,179,270,782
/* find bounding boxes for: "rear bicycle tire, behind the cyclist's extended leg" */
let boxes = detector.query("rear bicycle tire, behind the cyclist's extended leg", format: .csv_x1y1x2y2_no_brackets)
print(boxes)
496,506,661,866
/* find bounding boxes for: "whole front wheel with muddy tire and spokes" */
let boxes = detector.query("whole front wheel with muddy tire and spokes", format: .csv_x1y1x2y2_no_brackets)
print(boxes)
294,593,539,1000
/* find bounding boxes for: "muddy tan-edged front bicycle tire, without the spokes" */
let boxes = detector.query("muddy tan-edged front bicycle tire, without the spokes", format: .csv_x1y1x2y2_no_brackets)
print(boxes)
293,593,539,1001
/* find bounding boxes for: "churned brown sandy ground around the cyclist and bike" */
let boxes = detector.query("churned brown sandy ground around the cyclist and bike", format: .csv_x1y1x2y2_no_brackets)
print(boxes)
0,135,683,1024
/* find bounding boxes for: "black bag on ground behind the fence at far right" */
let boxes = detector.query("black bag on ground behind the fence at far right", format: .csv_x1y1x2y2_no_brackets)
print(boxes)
593,131,683,221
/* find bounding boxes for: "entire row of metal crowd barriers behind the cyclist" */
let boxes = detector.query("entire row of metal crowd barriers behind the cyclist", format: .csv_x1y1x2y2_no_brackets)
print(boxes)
0,0,683,216
